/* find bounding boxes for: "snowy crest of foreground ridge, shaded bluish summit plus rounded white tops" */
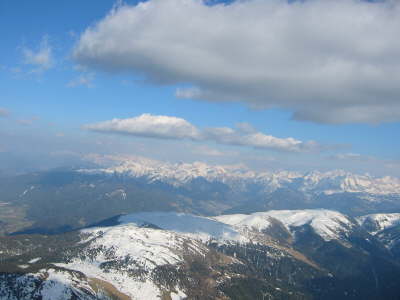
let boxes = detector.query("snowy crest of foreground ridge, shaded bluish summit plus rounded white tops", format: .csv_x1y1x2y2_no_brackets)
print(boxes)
89,209,356,243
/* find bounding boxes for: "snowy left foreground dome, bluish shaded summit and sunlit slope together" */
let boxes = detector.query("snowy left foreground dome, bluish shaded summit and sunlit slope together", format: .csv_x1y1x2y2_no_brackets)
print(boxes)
0,212,340,300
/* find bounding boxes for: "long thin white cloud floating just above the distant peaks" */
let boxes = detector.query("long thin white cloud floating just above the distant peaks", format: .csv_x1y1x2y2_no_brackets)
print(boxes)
84,114,323,152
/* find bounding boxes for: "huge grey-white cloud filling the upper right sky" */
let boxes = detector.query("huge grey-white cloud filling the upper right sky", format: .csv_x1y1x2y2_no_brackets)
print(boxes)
73,0,400,123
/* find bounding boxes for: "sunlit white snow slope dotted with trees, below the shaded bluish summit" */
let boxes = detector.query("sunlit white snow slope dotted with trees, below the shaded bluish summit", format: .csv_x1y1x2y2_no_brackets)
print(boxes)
57,221,212,299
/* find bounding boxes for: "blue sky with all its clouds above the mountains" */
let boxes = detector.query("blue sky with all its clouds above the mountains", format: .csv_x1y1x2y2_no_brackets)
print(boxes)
0,0,400,176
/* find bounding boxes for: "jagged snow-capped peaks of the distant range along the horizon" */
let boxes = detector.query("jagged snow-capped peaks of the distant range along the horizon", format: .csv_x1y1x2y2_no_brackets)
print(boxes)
80,158,400,195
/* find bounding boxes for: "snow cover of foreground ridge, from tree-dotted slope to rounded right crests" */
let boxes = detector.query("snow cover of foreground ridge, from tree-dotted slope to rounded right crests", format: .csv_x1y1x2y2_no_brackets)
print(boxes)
65,209,357,290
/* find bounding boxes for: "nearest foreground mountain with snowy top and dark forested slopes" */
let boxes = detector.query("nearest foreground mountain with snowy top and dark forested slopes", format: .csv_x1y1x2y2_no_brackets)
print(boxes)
0,209,400,300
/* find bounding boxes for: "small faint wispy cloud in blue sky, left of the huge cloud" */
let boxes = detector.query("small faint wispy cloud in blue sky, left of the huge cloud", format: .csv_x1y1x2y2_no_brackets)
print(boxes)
22,36,54,73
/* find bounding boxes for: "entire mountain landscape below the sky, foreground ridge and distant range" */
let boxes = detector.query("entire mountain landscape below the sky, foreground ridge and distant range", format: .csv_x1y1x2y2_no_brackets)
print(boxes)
0,158,400,300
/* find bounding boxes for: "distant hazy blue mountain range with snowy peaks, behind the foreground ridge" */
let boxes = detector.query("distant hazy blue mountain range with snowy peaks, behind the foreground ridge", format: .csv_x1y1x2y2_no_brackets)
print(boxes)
0,158,400,234
